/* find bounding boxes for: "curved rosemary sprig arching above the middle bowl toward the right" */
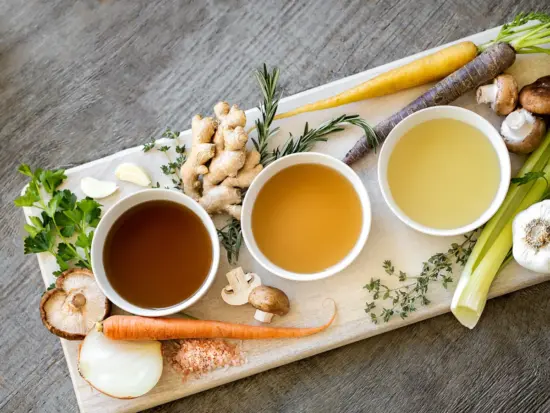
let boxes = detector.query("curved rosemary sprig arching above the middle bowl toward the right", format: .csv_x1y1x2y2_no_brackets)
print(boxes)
267,115,379,163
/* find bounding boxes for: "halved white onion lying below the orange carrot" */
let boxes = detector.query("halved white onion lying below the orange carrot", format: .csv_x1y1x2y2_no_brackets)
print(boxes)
78,328,162,399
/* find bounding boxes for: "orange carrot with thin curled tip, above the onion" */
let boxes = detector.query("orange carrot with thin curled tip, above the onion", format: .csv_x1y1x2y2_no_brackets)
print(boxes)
99,307,336,340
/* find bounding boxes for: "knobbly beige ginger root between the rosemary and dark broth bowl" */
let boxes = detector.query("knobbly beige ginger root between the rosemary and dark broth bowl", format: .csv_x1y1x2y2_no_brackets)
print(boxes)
181,102,263,219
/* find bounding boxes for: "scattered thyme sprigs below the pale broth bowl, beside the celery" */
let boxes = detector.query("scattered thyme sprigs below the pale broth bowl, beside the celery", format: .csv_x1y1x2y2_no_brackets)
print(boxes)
363,231,477,324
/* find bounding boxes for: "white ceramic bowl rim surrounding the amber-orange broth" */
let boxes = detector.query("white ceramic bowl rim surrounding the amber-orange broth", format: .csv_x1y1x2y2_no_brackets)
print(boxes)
241,152,371,281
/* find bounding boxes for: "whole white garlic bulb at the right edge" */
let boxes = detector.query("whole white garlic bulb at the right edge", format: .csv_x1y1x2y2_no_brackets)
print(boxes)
512,201,550,273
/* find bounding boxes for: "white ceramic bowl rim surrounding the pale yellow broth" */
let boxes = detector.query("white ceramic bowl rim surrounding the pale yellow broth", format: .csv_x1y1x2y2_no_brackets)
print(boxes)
378,106,511,236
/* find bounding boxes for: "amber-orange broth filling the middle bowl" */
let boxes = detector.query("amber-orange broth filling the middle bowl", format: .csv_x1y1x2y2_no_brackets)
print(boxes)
252,164,363,274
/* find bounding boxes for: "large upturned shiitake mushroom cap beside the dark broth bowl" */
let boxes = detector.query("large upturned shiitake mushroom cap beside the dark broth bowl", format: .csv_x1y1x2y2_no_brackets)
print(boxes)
40,268,111,340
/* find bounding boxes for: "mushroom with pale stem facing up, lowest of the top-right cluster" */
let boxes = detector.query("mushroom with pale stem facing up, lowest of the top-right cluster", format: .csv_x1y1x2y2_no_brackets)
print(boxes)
500,108,546,154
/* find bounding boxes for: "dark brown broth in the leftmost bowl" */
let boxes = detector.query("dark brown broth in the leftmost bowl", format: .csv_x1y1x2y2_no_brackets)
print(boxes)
103,201,212,308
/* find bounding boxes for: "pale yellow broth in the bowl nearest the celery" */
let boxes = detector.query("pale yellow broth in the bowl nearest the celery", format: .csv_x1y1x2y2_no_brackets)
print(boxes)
388,119,500,229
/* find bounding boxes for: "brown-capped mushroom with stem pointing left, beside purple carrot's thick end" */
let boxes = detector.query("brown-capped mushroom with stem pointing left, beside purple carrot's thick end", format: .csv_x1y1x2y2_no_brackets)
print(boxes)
476,75,518,115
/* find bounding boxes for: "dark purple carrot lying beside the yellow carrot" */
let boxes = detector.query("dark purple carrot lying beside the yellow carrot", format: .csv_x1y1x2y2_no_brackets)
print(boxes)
343,43,516,165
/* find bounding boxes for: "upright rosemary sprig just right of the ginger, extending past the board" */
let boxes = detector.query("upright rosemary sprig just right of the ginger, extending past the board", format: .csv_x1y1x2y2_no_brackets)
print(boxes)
252,63,281,166
